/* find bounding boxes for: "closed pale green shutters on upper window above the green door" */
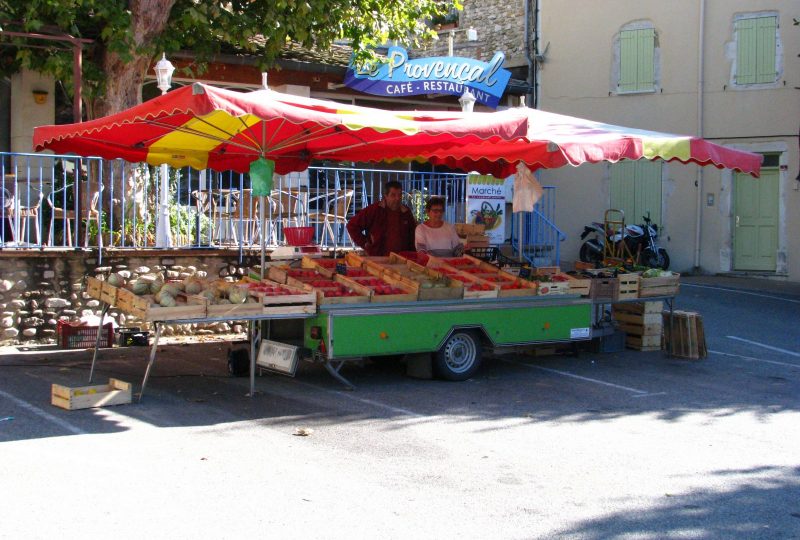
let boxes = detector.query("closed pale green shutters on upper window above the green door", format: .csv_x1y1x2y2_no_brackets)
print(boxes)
735,17,778,84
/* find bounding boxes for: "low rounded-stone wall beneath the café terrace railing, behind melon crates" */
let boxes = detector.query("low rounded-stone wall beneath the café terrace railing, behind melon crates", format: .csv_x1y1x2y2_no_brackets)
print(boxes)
0,251,247,344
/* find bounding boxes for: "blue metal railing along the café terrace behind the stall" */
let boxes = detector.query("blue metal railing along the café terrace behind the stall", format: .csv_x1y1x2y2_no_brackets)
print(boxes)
0,153,563,264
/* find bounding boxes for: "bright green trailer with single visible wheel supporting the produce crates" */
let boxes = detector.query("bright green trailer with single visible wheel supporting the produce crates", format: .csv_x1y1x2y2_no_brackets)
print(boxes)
303,295,592,387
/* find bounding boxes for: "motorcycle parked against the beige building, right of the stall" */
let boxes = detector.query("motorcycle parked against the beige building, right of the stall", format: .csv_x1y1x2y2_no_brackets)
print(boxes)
578,213,669,270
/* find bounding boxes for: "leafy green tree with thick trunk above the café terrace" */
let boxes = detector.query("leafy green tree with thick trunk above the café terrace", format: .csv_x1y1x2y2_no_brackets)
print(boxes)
0,0,460,117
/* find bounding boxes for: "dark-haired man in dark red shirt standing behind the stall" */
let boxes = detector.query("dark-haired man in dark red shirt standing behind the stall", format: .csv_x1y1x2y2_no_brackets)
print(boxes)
347,180,417,255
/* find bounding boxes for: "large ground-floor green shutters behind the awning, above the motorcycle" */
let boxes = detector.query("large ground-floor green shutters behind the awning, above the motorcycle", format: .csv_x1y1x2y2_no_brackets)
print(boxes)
610,159,662,226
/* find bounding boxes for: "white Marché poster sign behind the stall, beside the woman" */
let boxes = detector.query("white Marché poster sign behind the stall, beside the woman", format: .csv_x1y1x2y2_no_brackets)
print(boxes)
467,174,506,245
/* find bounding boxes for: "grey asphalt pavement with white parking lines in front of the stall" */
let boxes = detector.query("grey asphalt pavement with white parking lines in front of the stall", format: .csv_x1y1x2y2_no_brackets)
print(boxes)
0,281,800,539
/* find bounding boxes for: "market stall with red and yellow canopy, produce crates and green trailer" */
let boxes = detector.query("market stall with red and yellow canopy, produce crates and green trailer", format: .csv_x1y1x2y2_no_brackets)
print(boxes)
34,84,761,396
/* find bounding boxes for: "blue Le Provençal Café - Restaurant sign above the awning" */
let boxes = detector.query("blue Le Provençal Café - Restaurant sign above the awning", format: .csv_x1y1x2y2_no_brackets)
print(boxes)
344,47,511,107
